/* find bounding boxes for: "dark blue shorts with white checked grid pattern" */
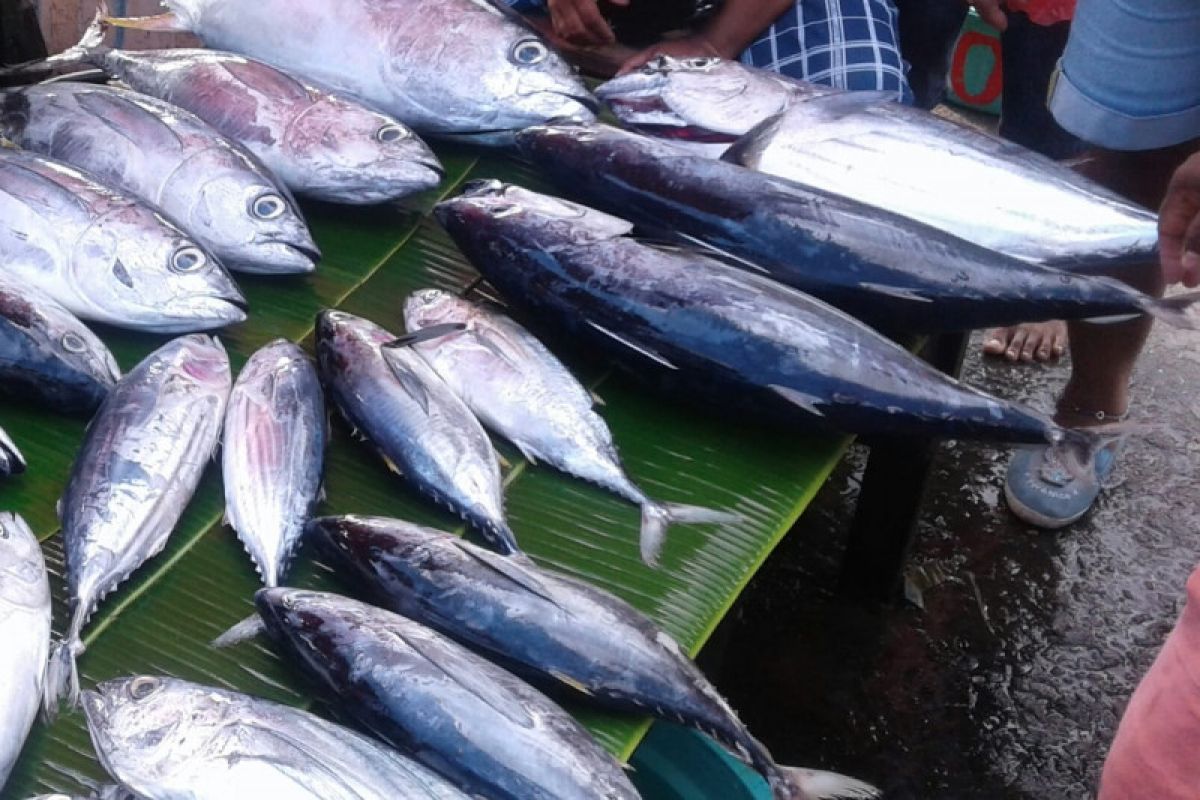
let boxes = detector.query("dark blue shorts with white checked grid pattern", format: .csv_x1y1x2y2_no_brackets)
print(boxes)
504,0,907,103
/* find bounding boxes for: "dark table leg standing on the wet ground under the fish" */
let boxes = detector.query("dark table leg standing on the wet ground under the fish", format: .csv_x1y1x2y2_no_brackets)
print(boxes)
839,333,968,602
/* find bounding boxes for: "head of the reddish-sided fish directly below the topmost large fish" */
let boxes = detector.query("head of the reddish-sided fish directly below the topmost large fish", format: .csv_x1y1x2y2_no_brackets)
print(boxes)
283,97,444,203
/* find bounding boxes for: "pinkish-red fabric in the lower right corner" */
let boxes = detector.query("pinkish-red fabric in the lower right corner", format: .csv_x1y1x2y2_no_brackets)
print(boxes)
1097,569,1200,800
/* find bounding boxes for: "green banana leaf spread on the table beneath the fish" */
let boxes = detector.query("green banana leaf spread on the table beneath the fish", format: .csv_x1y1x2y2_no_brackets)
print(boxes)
0,146,846,800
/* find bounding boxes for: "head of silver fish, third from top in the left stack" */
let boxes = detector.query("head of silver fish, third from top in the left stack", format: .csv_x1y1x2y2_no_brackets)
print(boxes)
174,149,320,275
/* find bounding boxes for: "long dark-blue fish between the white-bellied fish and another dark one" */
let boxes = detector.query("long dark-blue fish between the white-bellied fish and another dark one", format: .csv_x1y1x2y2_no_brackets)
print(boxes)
517,125,1200,332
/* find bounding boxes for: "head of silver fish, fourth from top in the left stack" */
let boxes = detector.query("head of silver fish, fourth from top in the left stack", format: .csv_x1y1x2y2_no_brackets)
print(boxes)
70,204,246,332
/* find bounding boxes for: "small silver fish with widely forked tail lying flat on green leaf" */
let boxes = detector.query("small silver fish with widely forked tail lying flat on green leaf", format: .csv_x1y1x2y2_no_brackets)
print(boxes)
403,289,740,565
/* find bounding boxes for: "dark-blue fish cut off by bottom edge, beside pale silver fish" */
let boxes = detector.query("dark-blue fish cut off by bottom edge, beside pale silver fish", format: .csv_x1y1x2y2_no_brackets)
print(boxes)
254,587,641,800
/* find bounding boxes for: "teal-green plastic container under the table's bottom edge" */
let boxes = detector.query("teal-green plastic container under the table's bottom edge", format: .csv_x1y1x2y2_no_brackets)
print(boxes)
630,722,772,800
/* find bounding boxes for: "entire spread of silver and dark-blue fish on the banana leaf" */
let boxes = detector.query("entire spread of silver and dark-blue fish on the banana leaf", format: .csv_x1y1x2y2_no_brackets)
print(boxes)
0,0,1200,800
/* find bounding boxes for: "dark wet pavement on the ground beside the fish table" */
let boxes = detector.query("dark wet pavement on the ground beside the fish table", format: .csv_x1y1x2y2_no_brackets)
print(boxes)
708,325,1200,800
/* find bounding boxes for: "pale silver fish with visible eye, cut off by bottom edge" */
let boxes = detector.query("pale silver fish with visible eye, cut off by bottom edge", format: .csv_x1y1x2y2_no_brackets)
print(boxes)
83,675,468,800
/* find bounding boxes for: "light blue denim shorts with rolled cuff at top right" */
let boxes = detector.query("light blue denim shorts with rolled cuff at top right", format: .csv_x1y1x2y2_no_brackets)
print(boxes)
1050,0,1200,150
